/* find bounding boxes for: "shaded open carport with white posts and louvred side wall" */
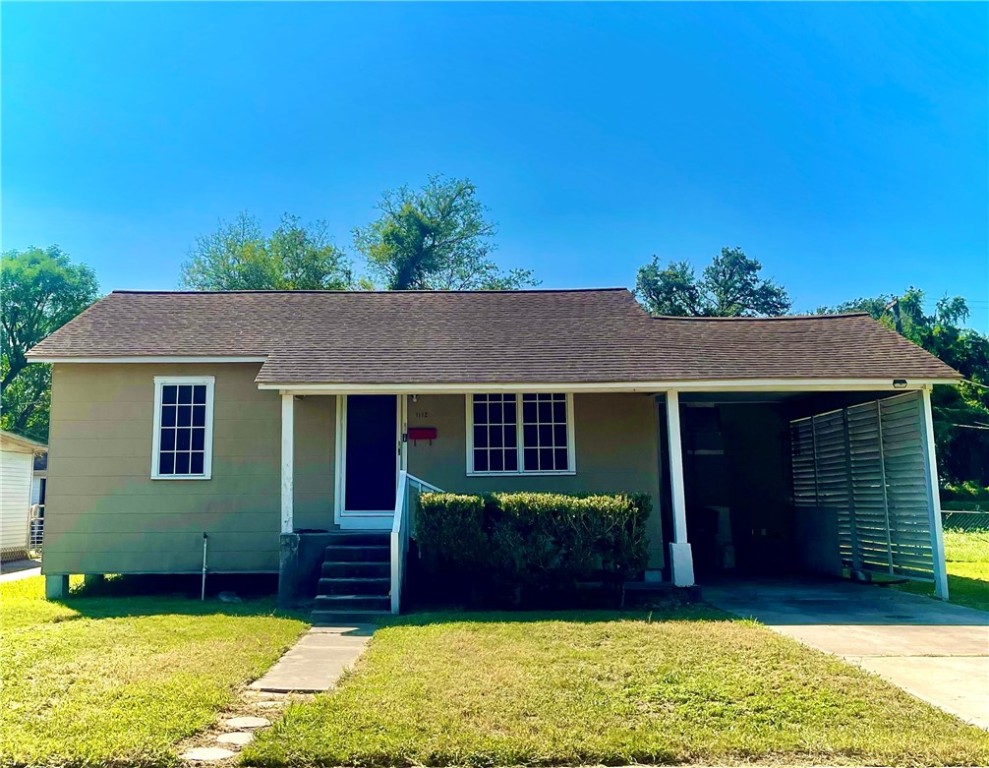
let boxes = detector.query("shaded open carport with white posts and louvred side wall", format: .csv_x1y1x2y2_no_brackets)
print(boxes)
661,388,948,598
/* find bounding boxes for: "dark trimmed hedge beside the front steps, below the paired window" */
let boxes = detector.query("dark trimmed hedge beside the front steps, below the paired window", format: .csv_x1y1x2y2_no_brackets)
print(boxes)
414,493,651,604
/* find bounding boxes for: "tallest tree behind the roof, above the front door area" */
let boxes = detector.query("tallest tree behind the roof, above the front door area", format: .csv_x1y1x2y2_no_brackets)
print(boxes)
354,176,536,290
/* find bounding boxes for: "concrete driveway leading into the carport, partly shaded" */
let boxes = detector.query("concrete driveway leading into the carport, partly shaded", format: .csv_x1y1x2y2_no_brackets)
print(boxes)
704,581,989,729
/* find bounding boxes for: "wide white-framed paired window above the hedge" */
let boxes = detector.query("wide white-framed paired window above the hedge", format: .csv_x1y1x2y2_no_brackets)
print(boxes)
467,393,575,475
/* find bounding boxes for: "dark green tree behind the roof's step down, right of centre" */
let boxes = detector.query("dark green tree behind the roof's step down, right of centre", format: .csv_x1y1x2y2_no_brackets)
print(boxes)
635,248,790,317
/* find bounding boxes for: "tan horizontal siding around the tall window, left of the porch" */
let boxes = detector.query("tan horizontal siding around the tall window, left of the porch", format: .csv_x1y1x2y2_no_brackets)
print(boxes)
44,364,284,573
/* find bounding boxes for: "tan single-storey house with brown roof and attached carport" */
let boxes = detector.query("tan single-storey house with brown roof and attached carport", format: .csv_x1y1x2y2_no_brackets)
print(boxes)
29,289,958,610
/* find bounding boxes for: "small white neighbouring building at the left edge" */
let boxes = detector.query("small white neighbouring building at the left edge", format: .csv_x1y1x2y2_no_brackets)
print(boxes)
0,430,47,561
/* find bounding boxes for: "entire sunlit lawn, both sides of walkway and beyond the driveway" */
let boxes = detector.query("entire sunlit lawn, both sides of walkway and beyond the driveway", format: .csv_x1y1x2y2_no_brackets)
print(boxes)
7,531,989,768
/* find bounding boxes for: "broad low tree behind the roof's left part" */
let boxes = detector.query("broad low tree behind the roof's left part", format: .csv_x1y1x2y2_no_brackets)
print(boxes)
180,213,353,291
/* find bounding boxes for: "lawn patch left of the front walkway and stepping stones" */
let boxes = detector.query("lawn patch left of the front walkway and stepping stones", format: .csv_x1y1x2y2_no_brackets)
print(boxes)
0,576,305,768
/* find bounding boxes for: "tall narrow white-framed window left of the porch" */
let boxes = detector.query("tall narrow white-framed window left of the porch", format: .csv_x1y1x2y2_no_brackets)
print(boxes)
151,376,213,480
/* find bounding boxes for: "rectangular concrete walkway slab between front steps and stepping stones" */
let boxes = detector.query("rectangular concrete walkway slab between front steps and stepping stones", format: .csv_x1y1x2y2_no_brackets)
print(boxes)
250,625,375,693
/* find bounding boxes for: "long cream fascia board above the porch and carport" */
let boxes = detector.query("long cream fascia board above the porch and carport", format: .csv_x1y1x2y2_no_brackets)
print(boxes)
258,378,957,395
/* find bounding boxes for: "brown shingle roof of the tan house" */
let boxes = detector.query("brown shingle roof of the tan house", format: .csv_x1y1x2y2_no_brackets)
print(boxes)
29,289,958,384
